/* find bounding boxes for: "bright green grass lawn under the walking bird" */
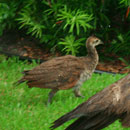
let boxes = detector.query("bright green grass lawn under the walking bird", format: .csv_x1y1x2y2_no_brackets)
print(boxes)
0,58,126,130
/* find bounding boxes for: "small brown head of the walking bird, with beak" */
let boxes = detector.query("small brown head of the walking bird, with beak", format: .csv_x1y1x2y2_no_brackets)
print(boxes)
86,36,103,47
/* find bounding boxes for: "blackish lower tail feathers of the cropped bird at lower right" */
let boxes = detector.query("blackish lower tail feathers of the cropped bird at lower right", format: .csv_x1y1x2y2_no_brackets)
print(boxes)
65,113,117,130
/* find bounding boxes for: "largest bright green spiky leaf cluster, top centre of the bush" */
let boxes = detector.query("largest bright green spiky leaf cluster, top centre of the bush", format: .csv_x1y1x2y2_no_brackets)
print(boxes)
57,6,93,35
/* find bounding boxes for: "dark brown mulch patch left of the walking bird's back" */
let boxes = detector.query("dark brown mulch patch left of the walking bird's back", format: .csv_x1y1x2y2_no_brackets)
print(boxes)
0,33,58,60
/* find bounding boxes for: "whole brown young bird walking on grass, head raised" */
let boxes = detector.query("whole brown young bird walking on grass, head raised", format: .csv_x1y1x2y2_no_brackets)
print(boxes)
17,36,102,103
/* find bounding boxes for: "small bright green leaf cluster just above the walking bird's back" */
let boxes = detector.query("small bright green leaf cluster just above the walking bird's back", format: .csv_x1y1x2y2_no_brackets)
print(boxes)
58,35,85,56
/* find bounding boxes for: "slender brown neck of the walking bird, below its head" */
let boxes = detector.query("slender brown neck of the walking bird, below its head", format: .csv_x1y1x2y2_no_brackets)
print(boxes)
87,46,99,71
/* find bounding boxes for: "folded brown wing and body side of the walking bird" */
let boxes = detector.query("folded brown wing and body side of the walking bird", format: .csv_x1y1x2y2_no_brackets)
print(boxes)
18,55,84,89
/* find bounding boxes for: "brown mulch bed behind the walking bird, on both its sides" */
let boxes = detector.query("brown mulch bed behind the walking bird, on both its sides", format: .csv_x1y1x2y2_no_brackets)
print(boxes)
0,33,130,73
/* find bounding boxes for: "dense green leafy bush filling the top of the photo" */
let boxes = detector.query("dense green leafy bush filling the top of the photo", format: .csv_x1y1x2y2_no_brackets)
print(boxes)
0,0,130,55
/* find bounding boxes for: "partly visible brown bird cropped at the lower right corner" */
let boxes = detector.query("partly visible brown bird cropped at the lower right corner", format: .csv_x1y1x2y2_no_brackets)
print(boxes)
51,74,130,130
